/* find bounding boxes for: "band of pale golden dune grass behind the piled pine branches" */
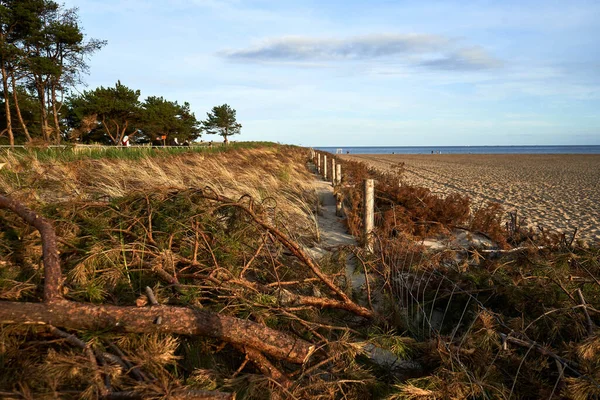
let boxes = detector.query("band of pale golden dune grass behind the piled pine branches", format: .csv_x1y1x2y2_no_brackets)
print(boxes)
0,147,316,241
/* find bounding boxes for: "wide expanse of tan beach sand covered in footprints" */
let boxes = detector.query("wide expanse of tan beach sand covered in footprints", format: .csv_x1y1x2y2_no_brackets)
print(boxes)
341,154,600,243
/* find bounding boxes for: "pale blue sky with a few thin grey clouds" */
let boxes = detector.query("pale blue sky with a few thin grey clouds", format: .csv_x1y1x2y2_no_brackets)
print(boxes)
65,0,600,146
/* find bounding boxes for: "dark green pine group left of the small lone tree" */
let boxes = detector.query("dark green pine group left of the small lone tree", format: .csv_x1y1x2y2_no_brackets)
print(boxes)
0,0,211,145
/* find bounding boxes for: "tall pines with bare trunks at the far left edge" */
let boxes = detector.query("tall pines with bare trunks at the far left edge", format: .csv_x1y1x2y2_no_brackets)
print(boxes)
0,0,106,145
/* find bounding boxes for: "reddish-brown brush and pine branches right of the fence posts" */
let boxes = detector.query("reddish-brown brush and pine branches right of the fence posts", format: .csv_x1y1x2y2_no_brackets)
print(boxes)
328,152,600,399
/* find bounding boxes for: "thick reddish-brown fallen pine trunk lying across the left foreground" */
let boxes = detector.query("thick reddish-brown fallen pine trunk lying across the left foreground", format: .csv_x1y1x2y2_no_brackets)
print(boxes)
0,300,315,364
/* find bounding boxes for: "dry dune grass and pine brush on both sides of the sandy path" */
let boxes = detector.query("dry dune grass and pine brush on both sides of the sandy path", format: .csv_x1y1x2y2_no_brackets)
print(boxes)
0,144,600,400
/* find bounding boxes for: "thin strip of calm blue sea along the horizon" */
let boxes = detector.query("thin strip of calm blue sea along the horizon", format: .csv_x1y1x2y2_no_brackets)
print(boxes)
315,146,600,154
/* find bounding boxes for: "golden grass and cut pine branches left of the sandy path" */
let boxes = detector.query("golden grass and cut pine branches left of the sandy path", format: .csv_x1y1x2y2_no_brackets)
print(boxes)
0,146,412,399
